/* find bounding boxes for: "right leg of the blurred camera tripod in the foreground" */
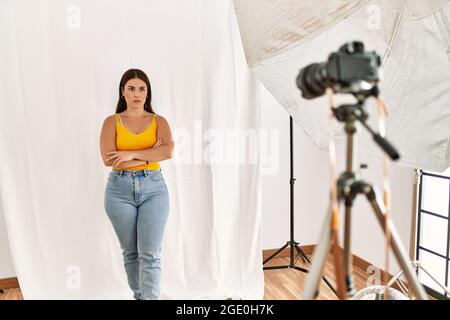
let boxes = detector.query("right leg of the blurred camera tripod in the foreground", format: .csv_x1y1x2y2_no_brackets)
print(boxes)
364,185,428,300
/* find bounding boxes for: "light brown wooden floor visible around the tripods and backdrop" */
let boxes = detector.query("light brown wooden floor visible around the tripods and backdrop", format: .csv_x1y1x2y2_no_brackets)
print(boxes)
0,257,367,300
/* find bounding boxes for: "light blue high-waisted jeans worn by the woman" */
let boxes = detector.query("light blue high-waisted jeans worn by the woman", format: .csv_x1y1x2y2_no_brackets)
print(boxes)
104,169,169,300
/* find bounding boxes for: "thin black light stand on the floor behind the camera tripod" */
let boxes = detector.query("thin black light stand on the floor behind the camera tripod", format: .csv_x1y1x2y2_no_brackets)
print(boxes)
263,117,336,294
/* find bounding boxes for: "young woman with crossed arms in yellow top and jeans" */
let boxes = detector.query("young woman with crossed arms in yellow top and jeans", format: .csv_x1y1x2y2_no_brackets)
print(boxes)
100,69,174,300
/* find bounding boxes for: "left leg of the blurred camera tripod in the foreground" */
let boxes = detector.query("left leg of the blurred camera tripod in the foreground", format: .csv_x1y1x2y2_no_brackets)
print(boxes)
302,205,331,300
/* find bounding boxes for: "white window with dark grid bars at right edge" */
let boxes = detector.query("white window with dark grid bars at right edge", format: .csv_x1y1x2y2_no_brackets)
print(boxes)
416,169,450,298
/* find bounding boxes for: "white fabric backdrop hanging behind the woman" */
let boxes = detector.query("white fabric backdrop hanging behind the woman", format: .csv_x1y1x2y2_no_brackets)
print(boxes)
0,0,264,299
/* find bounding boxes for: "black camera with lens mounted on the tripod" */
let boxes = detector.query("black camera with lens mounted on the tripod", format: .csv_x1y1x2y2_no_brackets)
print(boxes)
297,41,381,99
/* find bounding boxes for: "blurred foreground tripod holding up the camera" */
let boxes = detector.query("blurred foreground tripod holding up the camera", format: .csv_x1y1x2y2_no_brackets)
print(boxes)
303,95,427,300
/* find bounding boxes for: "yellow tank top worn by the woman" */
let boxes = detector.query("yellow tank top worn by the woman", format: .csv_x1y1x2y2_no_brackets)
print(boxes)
113,113,160,170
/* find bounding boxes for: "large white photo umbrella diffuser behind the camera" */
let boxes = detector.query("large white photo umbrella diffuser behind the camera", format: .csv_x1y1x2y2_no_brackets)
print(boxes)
233,0,450,171
